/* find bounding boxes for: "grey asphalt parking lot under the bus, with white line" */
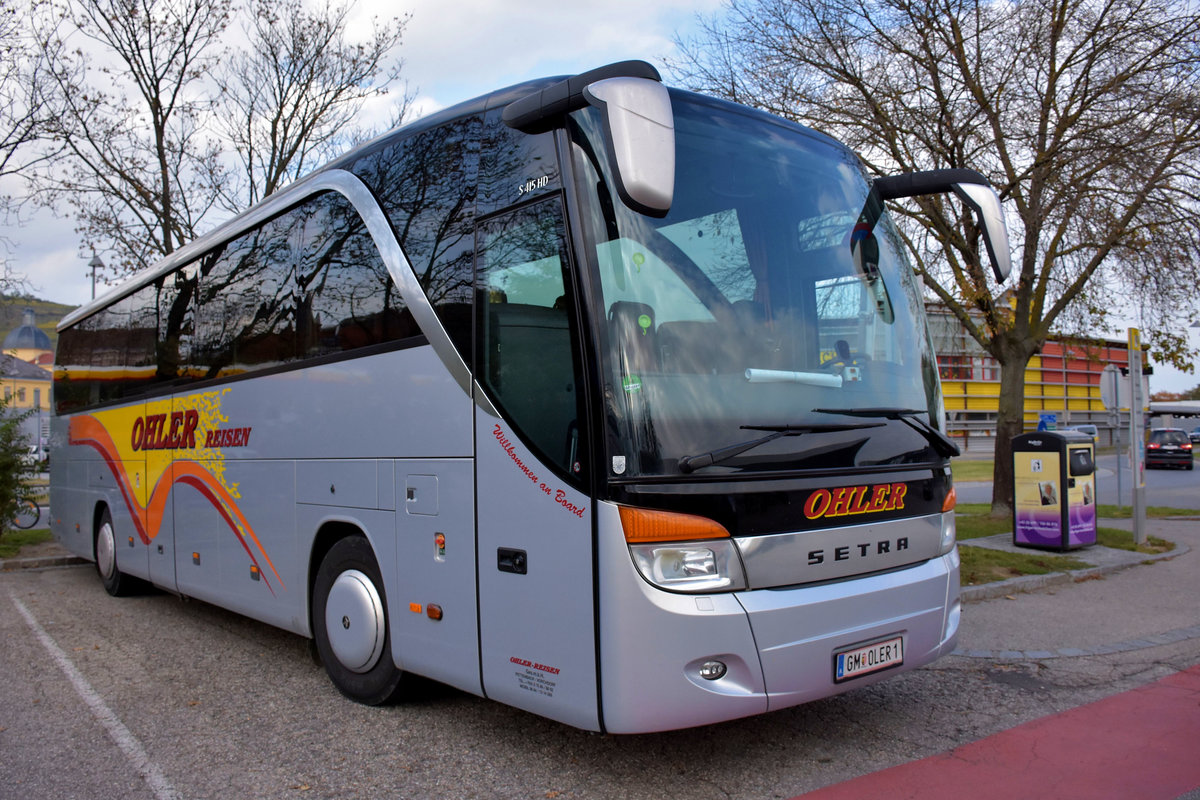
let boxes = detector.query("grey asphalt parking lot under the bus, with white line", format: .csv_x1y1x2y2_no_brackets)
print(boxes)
0,522,1200,799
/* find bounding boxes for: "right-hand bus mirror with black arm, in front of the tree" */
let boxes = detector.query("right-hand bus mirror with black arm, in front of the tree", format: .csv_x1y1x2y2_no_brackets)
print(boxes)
872,169,1013,283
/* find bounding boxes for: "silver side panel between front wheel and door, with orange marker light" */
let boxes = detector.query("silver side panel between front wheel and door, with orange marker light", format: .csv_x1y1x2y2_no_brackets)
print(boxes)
388,458,482,694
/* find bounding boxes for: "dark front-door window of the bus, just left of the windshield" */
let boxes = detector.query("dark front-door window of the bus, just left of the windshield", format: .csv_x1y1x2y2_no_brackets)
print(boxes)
475,198,580,480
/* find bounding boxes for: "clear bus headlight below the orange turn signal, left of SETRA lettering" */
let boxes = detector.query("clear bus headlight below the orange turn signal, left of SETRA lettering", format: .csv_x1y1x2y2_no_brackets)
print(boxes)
629,539,746,593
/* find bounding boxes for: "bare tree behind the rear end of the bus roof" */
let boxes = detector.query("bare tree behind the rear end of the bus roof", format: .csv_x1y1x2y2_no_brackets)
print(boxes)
41,0,230,275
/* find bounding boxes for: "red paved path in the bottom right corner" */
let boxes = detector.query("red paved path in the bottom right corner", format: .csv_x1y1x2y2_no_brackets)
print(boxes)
804,664,1200,800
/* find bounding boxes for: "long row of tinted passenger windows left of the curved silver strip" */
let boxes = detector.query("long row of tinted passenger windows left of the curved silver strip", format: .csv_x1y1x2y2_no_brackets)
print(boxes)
55,193,412,414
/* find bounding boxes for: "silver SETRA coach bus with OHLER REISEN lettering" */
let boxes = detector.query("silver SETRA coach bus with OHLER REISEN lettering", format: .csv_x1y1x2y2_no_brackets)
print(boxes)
50,61,1008,733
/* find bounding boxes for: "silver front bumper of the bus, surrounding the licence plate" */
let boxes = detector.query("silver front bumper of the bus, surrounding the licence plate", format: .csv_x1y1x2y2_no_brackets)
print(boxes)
598,504,961,733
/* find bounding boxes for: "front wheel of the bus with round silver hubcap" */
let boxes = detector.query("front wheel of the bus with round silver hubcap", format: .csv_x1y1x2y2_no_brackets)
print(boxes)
312,536,403,705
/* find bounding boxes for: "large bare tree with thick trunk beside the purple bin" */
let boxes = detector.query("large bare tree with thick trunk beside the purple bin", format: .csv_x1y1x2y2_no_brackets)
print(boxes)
677,0,1200,513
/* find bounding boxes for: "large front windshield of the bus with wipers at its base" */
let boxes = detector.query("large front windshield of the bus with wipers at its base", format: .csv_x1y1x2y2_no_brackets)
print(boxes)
571,92,942,480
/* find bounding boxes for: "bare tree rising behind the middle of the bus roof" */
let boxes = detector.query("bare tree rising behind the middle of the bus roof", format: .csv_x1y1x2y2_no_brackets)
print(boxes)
220,0,410,204
